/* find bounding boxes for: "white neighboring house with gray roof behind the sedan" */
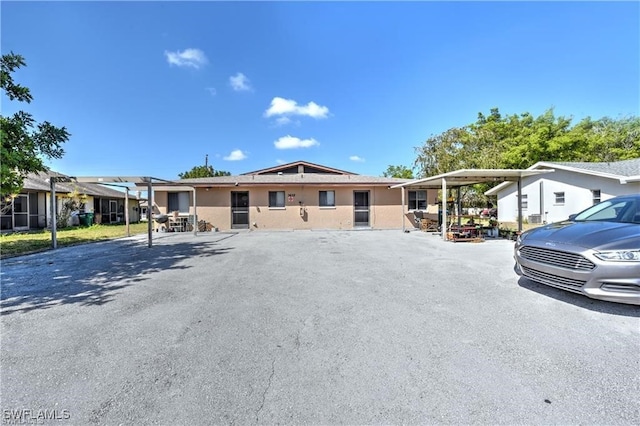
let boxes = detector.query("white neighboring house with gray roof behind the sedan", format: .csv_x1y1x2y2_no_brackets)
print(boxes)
485,158,640,223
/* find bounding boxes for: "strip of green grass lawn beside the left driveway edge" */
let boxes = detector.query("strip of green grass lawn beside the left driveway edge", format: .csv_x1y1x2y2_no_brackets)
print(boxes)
0,222,147,258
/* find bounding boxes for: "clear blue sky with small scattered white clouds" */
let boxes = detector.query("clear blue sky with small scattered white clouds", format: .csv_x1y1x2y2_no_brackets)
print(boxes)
1,1,640,179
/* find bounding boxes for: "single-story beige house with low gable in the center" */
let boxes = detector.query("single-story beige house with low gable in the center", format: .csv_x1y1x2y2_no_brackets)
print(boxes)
154,161,416,230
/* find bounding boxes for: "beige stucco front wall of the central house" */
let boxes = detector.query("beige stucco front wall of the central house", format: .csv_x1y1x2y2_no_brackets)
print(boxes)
154,185,413,230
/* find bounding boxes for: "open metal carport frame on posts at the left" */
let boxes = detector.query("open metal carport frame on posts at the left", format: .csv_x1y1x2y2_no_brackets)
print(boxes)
49,176,182,249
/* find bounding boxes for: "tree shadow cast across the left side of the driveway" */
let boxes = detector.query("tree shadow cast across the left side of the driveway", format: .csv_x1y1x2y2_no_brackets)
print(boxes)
0,239,235,315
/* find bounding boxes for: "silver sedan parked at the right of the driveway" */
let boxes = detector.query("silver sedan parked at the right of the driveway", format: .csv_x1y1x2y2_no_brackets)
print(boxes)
514,194,640,305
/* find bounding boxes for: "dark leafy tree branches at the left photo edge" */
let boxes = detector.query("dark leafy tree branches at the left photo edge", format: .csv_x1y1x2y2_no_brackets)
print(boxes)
0,52,70,195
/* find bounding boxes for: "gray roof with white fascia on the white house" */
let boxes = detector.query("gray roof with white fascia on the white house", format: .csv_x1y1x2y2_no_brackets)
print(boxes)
485,158,640,195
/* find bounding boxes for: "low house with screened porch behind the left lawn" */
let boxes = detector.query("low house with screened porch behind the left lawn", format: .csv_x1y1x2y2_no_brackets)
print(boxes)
0,171,140,232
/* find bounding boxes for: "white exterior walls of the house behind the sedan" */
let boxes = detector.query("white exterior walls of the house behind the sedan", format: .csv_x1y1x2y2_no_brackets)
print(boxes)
498,169,640,223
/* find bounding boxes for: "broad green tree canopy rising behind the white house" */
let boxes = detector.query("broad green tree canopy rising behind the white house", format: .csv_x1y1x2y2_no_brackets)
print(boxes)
414,108,640,176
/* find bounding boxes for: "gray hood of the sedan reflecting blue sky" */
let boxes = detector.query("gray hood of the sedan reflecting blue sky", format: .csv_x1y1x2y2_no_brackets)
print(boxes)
523,221,640,250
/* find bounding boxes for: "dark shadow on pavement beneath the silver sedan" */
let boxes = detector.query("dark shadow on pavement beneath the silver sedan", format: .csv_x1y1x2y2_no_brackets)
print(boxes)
518,277,640,318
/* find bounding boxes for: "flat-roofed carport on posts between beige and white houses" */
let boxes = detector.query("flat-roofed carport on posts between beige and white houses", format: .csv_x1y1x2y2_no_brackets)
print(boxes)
390,169,554,240
